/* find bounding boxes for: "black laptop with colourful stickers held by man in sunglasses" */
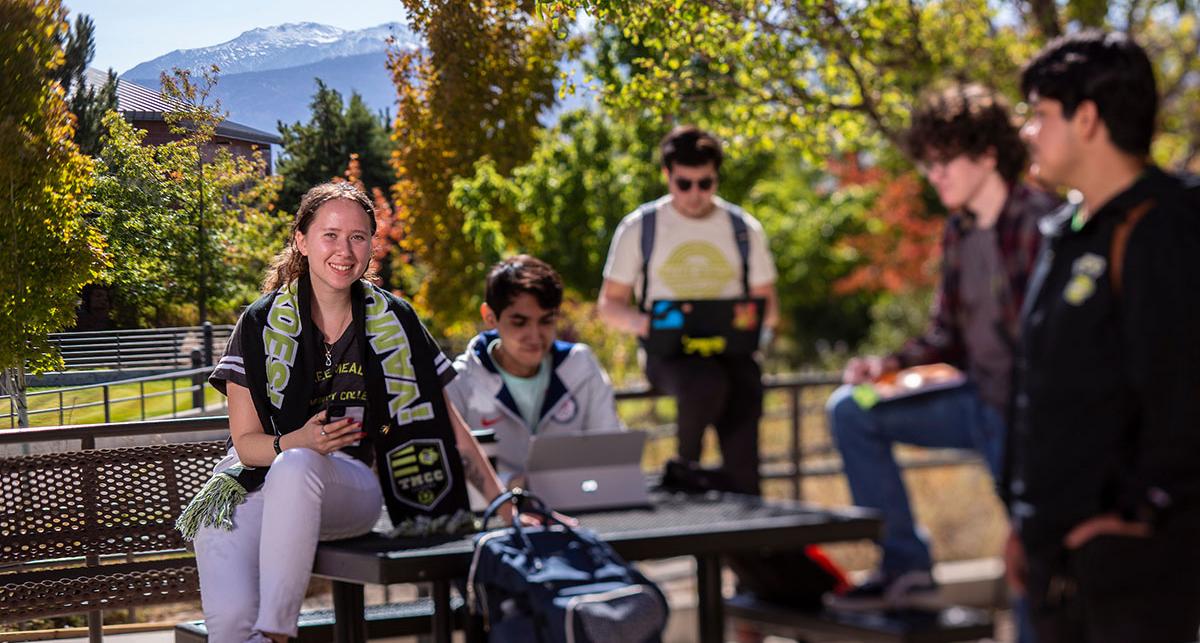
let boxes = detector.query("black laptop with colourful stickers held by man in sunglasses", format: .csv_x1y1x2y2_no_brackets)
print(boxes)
642,298,767,357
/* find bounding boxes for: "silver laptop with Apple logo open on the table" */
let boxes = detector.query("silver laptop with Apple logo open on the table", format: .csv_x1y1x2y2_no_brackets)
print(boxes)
526,431,650,512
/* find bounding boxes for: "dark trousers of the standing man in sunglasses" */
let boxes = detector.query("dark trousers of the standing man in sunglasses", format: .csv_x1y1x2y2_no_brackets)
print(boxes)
646,355,763,495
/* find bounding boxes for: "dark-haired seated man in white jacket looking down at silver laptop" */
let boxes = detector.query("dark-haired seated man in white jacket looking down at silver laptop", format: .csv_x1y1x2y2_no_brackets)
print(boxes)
446,254,623,487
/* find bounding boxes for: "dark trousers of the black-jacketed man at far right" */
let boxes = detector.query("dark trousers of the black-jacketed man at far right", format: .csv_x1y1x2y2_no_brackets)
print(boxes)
1027,518,1200,643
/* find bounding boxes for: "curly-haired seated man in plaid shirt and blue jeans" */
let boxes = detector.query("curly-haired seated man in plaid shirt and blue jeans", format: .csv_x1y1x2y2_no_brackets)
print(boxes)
828,85,1058,609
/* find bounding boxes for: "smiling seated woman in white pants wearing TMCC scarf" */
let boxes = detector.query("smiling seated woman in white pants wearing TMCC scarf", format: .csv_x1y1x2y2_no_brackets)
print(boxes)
178,184,502,642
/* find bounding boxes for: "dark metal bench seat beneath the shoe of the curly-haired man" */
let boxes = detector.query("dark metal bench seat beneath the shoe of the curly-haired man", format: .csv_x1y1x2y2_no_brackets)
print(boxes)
725,594,994,643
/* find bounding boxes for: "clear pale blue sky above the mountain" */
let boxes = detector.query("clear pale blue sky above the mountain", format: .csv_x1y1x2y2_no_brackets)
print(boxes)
64,0,404,73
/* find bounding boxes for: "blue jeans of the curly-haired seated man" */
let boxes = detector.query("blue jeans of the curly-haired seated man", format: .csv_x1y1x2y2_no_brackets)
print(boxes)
826,384,1004,575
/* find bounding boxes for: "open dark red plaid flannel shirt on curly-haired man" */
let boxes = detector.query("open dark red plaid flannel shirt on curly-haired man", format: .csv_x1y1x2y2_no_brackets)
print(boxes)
894,184,1062,368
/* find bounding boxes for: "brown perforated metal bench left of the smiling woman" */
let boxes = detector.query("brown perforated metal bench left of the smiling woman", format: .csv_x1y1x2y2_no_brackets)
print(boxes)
0,440,226,641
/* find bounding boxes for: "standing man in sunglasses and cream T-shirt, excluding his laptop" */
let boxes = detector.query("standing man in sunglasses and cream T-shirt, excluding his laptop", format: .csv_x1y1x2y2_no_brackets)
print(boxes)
599,126,778,494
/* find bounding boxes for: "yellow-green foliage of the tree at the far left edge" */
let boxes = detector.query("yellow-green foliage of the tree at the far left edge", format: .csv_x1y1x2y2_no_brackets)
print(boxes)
0,0,102,422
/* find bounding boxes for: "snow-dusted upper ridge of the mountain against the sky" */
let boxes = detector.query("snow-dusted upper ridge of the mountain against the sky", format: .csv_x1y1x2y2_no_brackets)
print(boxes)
121,23,418,79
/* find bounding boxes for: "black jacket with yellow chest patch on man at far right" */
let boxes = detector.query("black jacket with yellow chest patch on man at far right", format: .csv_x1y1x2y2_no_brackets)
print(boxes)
1007,168,1200,551
